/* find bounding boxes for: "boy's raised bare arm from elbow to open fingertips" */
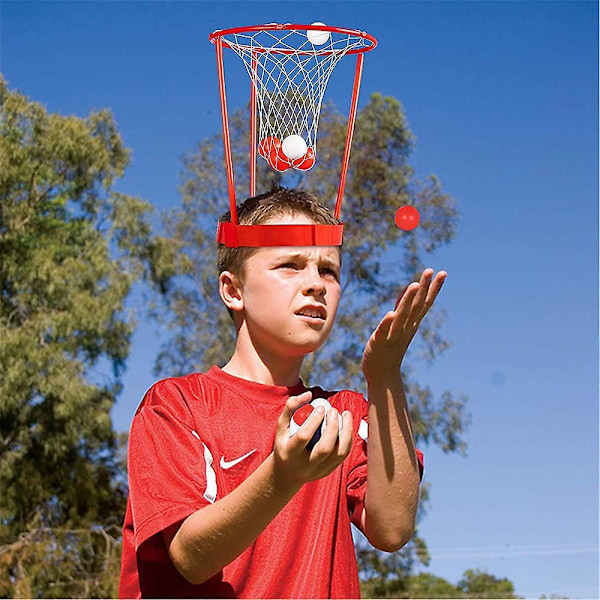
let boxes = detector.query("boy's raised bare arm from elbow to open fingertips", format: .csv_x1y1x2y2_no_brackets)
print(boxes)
361,269,447,552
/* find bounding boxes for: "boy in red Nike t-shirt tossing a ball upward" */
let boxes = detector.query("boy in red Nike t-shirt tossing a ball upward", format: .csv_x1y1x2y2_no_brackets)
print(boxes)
119,188,446,598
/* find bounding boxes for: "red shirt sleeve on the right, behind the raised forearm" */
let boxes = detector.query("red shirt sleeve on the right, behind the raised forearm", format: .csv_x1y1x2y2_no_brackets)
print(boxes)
346,393,424,531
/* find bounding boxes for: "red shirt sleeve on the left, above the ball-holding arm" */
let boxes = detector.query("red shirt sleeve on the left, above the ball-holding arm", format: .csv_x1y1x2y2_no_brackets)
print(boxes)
128,380,216,550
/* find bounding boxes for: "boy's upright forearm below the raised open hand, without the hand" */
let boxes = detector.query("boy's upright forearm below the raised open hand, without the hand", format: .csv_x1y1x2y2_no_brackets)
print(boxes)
365,372,420,552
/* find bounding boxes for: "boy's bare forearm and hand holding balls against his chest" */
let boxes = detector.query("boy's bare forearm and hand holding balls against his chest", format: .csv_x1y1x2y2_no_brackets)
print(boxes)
163,392,353,584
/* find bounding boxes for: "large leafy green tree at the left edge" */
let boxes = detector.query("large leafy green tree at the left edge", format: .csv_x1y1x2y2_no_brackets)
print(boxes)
0,76,184,597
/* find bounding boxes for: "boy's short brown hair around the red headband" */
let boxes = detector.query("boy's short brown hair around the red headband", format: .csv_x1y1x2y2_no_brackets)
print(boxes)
217,185,342,323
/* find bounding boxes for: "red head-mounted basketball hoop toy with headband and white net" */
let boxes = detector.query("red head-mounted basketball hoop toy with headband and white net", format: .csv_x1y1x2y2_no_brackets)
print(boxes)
209,23,377,248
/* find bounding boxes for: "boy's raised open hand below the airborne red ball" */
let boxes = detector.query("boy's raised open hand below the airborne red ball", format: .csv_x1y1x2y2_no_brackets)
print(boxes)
362,269,448,382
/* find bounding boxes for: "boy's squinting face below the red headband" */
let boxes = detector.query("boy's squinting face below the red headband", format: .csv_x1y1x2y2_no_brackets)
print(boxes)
221,215,341,356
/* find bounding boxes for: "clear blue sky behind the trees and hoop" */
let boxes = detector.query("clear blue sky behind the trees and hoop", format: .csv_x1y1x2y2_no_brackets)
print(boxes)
0,1,599,598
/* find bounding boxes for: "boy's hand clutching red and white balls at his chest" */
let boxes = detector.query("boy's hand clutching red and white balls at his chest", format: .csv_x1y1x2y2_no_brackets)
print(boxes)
273,391,353,486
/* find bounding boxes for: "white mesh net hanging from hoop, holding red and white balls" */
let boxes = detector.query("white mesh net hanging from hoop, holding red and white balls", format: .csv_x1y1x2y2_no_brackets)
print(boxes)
222,28,370,171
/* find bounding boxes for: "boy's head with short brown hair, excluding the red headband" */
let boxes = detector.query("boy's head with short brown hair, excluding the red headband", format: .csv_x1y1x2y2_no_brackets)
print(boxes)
217,188,342,349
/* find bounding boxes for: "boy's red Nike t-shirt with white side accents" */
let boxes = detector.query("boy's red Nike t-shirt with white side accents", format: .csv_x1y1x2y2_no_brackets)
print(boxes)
119,366,421,598
